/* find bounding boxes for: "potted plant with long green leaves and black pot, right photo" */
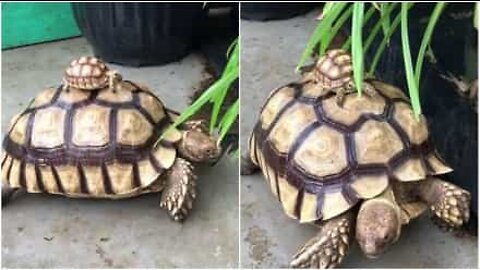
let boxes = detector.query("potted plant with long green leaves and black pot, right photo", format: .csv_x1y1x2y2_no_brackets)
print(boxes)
297,2,478,224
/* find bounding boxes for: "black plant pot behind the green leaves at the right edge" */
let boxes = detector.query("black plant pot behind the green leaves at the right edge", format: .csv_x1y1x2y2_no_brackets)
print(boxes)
365,3,478,216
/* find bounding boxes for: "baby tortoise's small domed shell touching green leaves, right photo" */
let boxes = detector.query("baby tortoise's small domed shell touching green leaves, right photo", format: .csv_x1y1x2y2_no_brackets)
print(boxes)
313,49,353,88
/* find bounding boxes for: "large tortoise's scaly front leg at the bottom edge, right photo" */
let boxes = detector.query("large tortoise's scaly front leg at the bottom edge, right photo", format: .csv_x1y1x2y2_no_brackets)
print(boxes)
290,210,355,268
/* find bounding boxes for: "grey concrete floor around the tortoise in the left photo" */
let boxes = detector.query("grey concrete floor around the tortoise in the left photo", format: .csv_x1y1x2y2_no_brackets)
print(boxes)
2,38,239,268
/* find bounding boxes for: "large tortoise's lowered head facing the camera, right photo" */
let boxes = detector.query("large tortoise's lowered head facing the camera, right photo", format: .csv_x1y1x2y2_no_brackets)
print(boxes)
356,199,402,259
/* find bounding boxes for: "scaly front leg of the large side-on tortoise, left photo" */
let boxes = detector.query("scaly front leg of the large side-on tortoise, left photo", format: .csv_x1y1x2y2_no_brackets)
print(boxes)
160,158,196,221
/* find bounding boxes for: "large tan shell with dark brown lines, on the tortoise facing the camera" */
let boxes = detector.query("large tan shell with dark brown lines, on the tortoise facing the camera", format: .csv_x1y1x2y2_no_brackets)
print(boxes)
249,77,451,222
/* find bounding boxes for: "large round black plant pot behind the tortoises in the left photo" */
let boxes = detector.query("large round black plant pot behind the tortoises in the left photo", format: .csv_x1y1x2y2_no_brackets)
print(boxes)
72,3,204,66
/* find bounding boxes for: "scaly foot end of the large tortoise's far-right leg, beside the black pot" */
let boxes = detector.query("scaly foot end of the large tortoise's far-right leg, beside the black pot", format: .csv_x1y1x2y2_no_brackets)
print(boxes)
431,182,470,228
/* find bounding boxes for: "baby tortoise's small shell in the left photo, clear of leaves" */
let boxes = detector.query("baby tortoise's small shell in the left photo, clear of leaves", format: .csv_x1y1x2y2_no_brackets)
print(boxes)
64,56,109,90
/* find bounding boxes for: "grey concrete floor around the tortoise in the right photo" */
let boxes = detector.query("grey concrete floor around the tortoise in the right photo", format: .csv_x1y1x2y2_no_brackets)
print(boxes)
240,8,478,268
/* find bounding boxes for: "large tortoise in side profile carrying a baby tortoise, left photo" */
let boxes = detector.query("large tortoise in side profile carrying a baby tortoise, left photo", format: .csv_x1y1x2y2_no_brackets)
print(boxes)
1,57,220,221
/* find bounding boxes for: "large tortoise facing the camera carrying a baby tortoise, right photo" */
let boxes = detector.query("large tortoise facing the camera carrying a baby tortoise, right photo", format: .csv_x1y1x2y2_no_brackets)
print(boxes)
242,50,470,268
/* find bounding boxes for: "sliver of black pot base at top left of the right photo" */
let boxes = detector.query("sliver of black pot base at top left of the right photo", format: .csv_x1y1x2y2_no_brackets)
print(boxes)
240,3,319,21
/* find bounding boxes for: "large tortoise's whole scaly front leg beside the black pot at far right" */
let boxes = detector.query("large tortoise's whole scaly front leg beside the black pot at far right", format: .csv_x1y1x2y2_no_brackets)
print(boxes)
418,178,471,228
